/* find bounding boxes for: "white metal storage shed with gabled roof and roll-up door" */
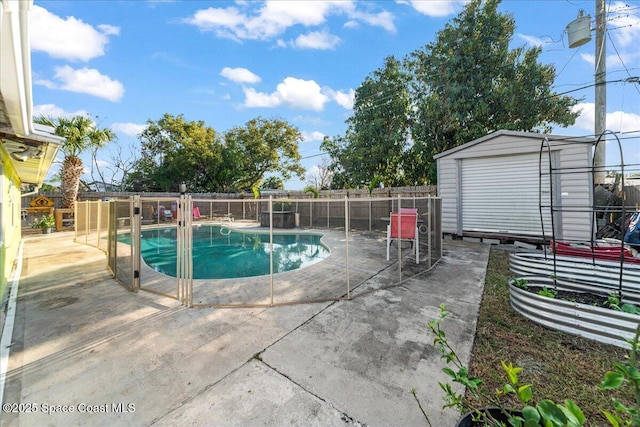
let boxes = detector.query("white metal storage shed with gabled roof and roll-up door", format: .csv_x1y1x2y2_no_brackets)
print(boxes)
434,130,594,241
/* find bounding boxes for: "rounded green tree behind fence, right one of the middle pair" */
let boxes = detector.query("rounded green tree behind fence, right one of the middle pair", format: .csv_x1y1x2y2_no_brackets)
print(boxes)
224,117,305,191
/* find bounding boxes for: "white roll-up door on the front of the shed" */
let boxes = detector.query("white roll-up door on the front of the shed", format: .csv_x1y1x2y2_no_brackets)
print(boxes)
460,153,551,236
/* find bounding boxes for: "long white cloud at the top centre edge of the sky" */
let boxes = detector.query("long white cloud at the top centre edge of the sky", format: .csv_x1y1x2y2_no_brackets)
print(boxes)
184,0,395,42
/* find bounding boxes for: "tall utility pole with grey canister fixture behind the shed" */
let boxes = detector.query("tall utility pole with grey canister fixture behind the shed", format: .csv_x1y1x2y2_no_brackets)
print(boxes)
567,0,607,185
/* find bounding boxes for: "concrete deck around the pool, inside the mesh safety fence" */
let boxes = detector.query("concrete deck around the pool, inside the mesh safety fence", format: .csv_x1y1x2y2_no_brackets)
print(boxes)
136,221,440,307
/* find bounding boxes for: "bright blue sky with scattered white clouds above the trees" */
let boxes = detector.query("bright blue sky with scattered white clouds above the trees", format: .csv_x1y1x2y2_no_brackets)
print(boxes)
30,0,640,190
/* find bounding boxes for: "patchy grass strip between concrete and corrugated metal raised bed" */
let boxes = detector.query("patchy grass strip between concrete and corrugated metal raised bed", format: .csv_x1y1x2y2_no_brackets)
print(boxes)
466,249,633,426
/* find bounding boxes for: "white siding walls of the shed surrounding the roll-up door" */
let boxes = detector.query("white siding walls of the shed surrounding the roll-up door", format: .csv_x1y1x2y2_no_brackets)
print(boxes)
437,131,593,240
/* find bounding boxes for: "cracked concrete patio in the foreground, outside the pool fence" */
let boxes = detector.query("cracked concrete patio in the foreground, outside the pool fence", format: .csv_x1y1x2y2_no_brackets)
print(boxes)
0,232,489,426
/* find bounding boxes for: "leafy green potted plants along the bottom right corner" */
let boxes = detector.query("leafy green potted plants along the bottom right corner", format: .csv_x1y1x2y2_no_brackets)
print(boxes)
428,304,640,427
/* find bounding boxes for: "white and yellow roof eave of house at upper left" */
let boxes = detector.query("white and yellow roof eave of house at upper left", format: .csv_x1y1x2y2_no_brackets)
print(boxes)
0,0,64,186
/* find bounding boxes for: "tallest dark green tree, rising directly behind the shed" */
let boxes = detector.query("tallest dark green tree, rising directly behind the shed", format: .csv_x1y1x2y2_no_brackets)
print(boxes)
406,0,578,183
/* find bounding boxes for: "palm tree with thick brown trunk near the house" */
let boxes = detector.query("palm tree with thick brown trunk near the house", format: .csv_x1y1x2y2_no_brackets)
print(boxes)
34,116,116,208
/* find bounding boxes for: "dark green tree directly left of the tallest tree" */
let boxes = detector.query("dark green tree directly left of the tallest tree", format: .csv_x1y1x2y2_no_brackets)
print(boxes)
322,56,411,187
